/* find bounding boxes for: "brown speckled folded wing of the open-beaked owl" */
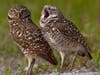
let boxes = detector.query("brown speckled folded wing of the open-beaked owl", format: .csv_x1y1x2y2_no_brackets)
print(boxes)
53,20,90,50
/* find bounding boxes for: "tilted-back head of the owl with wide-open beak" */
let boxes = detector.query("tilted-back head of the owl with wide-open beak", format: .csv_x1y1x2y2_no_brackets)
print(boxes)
40,5,63,27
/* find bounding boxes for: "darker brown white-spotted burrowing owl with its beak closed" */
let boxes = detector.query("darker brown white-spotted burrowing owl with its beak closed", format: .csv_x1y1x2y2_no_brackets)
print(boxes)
8,5,57,75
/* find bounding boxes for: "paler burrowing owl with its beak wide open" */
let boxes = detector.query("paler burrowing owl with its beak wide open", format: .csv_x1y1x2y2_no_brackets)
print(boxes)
40,5,92,68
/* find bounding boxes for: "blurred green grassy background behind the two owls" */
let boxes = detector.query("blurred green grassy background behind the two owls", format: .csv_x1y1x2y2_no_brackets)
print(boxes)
0,0,100,73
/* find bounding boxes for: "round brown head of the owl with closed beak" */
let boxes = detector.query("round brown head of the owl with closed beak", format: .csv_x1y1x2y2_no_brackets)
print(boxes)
8,4,31,20
